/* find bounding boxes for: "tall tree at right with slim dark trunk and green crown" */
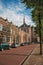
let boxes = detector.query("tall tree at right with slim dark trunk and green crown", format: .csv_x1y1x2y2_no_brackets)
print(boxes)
21,0,43,54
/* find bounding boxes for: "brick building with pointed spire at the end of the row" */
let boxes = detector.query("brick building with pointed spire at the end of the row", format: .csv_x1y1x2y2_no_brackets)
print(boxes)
19,17,39,42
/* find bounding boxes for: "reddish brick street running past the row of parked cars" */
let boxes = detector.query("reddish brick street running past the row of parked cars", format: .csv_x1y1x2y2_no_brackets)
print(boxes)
0,44,37,65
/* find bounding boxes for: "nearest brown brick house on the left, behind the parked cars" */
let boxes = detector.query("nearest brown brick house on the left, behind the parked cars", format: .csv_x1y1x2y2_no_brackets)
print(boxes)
0,17,18,44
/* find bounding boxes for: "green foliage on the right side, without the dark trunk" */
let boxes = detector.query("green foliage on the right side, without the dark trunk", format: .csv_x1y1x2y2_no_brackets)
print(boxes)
21,0,43,40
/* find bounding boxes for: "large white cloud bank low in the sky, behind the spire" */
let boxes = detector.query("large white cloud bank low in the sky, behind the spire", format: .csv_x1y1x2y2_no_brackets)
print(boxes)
0,3,33,26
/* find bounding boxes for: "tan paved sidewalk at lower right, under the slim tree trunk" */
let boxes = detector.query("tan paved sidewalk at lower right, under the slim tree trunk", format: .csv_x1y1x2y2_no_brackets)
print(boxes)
23,44,43,65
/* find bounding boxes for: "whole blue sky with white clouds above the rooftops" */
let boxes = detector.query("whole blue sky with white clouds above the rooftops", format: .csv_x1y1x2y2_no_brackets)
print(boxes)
0,0,34,26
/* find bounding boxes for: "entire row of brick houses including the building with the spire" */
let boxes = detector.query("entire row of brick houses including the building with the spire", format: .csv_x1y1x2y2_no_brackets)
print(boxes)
0,17,39,45
